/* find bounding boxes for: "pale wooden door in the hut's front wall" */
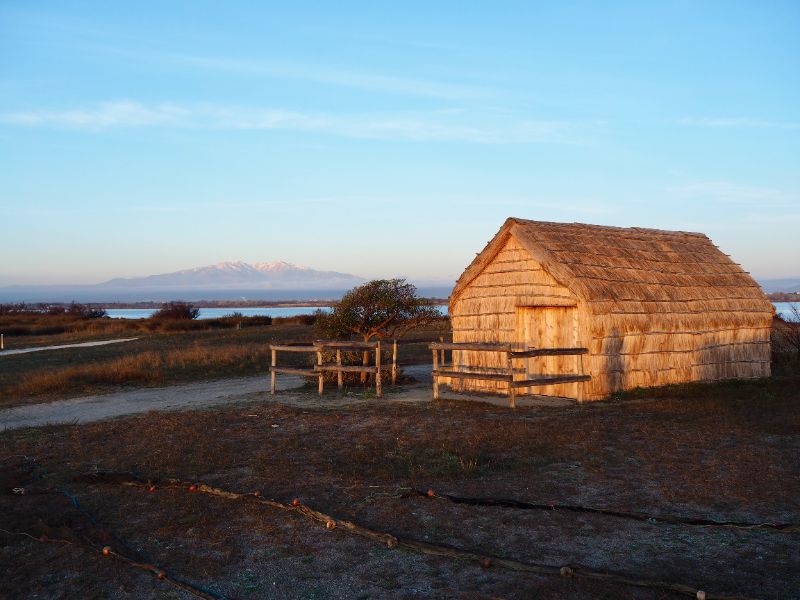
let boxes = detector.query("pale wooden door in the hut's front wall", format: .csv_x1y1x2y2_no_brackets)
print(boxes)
517,306,581,398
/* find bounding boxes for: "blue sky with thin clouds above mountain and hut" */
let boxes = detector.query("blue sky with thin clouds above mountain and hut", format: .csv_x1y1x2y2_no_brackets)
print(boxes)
0,0,800,284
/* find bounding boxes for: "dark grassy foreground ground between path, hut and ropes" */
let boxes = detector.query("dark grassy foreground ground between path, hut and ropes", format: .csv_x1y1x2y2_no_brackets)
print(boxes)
0,368,800,599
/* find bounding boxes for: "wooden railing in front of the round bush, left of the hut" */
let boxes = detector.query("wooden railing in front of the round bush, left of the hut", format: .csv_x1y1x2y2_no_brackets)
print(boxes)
270,340,397,398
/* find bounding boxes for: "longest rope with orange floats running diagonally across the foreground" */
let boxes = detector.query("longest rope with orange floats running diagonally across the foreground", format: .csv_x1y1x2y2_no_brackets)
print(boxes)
79,472,764,600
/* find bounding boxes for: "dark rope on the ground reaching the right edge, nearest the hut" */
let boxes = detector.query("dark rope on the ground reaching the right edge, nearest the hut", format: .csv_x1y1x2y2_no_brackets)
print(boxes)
413,490,800,533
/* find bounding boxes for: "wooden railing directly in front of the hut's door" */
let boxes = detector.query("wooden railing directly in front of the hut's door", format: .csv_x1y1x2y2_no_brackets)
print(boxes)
428,342,591,408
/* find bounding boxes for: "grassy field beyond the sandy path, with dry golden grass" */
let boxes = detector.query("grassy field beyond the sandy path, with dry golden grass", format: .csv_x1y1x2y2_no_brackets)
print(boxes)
0,319,448,408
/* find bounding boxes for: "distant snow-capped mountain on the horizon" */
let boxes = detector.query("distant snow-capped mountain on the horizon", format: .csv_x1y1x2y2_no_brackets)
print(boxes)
99,260,364,290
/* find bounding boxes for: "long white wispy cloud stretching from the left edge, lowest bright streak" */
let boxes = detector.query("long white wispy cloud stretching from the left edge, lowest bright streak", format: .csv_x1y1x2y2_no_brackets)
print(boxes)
0,100,578,144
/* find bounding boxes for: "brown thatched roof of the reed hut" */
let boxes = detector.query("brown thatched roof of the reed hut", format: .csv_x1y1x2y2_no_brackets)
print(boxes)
451,218,773,314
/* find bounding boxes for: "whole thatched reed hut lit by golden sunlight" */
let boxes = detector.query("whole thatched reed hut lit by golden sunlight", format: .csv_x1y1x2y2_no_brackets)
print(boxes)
450,218,774,400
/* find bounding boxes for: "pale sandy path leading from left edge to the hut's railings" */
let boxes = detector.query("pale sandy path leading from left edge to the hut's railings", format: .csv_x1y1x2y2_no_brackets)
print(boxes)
0,364,571,431
